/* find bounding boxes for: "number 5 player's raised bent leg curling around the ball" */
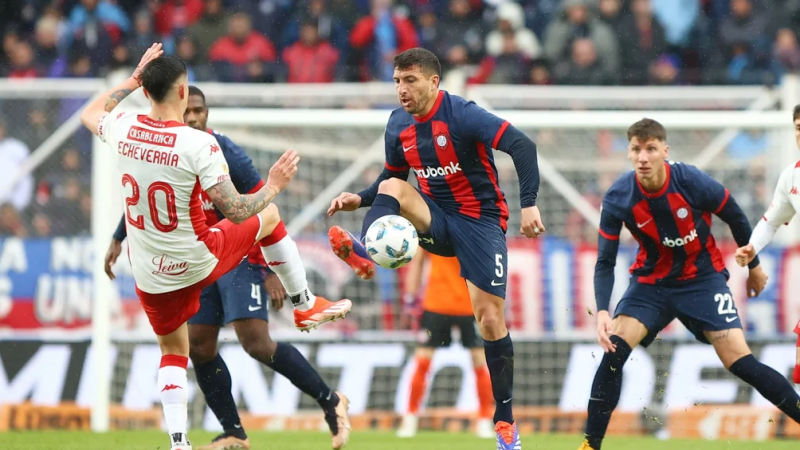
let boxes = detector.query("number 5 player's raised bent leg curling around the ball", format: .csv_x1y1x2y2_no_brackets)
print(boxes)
328,178,431,280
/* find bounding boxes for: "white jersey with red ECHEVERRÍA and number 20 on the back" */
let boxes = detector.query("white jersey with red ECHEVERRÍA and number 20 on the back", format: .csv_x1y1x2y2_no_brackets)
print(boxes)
97,111,229,294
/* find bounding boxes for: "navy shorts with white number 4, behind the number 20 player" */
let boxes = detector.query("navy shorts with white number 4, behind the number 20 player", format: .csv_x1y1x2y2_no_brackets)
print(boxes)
189,259,269,326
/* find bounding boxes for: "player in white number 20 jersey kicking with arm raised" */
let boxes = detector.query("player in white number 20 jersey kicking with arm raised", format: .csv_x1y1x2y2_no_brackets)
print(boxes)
81,44,352,450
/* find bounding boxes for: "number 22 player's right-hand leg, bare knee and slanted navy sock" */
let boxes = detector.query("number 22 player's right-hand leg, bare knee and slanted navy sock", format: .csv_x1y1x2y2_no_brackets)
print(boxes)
704,328,800,423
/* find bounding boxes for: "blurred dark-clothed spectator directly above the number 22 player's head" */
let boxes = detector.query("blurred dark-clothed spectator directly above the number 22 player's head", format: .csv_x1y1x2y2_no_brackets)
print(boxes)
618,0,667,85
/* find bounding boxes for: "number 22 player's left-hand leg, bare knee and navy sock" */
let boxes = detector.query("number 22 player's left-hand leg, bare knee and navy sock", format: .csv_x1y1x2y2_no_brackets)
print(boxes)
579,312,648,450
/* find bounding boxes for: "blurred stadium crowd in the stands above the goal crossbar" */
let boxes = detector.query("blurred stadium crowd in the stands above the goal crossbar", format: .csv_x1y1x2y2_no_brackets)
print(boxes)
0,0,800,85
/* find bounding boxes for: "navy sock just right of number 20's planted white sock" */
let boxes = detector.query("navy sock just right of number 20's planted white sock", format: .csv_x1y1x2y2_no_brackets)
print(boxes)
194,354,247,439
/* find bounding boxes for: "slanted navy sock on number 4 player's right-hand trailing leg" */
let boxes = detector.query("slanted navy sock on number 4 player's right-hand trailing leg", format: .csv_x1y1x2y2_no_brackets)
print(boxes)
261,342,339,411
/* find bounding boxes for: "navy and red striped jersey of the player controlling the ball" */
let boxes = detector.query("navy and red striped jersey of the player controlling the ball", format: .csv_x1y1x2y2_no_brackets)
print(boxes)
385,91,510,230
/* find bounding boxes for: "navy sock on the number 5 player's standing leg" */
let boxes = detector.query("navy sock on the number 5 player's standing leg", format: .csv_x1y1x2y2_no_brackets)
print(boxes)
483,333,514,423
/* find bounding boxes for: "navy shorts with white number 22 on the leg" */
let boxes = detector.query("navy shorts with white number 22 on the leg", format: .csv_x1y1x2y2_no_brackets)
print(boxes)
614,274,742,347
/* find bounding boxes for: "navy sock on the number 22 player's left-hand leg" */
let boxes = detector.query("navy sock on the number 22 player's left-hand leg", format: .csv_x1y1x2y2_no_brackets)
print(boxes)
586,335,631,450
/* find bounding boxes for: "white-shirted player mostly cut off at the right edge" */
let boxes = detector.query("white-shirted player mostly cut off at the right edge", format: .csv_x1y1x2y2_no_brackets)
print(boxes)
736,105,800,384
